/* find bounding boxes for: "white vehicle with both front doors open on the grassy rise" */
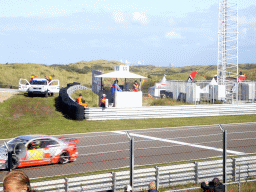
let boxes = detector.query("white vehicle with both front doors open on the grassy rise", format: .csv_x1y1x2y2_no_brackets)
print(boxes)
19,78,60,97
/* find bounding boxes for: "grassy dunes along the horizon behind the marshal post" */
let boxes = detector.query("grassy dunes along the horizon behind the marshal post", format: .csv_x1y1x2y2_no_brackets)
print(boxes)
0,60,256,91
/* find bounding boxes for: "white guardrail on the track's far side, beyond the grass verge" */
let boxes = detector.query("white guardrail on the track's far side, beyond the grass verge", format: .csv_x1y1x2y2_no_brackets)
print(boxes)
84,103,256,120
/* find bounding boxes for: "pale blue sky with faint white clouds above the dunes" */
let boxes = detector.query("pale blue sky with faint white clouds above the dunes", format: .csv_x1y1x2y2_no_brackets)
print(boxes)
0,0,256,67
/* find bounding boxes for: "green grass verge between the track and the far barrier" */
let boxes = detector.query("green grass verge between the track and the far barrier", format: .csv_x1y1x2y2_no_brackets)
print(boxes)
0,93,256,139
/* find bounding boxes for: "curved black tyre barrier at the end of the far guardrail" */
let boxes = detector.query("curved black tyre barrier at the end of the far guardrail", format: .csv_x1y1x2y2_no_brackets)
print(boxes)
59,82,84,121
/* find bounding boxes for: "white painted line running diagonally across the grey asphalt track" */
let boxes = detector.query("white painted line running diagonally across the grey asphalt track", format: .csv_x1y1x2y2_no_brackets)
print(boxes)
112,131,245,155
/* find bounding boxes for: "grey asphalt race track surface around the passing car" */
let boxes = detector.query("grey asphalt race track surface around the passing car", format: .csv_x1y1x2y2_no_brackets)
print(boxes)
0,123,256,181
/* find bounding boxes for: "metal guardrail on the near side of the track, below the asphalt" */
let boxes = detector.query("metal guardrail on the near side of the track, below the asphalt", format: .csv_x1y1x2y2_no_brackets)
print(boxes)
0,156,256,192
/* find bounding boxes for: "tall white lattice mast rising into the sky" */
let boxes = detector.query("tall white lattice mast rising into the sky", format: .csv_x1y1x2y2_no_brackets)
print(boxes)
217,0,238,102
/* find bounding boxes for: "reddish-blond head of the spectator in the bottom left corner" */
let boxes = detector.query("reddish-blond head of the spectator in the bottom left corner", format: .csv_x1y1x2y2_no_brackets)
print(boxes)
3,170,32,192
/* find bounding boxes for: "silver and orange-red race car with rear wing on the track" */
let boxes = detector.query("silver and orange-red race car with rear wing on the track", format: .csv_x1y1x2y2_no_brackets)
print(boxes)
0,135,78,169
